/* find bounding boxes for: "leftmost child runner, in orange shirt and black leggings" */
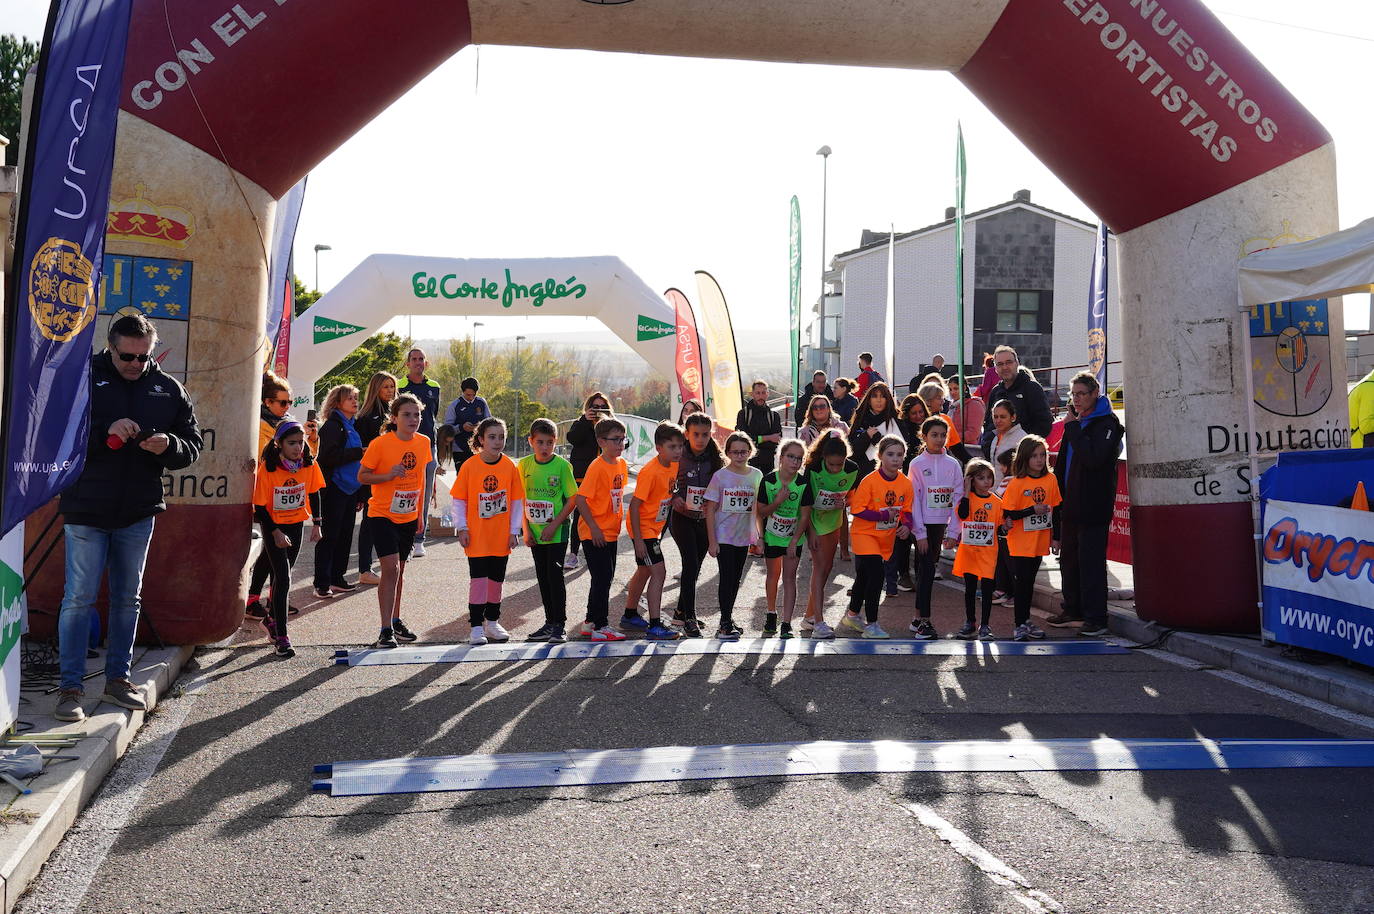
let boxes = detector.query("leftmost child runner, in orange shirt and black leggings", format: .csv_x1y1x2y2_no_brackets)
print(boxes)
253,419,324,657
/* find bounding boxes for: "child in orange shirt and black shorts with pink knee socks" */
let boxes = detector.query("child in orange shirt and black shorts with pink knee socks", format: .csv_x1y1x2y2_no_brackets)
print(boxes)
449,416,525,645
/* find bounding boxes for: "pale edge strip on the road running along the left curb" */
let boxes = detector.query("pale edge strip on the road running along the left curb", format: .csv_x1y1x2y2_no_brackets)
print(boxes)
14,650,234,914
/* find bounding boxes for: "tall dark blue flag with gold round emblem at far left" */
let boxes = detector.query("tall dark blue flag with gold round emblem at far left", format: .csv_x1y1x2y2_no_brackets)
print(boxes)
0,0,131,533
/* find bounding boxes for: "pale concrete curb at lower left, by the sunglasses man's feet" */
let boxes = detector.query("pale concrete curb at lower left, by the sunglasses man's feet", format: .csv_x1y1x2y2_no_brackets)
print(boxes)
0,647,195,914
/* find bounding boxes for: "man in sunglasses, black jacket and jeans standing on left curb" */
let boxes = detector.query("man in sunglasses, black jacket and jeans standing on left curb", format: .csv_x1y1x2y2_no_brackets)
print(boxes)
55,315,202,722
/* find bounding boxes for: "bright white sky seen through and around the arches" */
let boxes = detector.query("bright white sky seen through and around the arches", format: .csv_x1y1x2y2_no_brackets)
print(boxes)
10,0,1374,357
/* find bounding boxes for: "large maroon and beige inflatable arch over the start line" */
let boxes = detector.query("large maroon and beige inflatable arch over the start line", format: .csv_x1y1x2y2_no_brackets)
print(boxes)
30,0,1344,642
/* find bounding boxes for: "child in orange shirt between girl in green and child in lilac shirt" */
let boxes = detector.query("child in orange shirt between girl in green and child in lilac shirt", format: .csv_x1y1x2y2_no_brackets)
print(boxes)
840,434,911,638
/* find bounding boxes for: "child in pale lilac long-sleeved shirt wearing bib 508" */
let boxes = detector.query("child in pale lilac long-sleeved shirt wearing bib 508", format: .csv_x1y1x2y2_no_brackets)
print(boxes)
907,416,963,640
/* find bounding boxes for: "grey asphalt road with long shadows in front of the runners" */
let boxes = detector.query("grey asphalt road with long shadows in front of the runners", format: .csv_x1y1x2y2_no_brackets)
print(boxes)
19,542,1374,914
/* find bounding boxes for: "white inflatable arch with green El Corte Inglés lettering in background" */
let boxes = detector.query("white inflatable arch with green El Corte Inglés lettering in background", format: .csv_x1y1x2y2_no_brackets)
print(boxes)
289,254,676,397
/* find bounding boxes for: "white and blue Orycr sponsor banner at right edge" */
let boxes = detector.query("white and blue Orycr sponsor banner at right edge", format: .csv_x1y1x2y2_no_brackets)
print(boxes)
1261,500,1374,665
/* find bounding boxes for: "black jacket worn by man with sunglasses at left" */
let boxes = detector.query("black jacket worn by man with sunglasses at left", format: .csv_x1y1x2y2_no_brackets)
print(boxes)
59,350,203,531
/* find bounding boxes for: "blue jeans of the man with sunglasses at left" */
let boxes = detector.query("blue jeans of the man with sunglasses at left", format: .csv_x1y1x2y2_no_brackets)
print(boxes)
58,517,153,689
